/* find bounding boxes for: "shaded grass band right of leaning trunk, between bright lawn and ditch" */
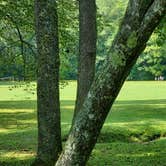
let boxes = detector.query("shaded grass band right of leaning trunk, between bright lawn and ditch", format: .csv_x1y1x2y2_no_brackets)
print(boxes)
106,99,166,124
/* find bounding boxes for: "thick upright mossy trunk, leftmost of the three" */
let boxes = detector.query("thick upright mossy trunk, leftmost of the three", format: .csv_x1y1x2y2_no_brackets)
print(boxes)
33,0,62,166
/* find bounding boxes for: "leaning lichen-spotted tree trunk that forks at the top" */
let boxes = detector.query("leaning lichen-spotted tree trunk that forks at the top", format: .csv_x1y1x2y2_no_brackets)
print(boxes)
56,0,166,166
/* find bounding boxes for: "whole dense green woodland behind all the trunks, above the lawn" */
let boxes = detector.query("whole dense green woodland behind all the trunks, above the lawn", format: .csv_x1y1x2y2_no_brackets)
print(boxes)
0,0,166,80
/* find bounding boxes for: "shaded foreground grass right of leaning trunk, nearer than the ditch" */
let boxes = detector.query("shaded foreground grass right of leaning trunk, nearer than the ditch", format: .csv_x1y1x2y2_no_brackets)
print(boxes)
87,139,166,166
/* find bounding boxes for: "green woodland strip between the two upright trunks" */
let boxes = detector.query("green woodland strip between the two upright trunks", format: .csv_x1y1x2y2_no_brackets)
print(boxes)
58,0,79,80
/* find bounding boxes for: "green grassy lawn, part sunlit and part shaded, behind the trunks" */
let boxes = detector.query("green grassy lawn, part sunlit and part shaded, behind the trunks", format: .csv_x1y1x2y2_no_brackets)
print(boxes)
0,81,166,166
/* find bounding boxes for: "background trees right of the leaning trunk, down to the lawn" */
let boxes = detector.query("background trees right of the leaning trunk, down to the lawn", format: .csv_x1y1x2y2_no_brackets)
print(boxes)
128,17,166,80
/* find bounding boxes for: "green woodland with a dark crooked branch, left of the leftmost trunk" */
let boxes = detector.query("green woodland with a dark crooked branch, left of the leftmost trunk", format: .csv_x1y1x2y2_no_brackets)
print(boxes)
0,0,36,80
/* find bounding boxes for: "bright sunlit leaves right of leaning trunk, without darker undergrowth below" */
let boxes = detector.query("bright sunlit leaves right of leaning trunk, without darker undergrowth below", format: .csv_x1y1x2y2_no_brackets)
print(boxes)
139,17,166,77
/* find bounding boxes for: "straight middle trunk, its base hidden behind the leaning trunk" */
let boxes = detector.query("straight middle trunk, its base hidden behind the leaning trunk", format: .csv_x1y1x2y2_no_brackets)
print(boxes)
73,0,97,123
